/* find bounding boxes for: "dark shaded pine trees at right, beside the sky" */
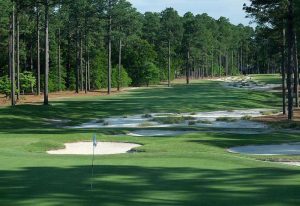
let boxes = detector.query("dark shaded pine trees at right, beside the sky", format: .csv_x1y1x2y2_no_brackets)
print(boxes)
244,0,300,120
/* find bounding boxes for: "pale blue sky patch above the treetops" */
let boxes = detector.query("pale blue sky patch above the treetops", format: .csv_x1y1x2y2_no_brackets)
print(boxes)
129,0,250,25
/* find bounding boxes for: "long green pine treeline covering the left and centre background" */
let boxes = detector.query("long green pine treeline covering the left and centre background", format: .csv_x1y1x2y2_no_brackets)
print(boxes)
0,0,255,105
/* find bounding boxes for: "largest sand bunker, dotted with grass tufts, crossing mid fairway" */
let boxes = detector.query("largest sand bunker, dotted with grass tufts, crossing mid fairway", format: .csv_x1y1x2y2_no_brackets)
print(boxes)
67,109,272,129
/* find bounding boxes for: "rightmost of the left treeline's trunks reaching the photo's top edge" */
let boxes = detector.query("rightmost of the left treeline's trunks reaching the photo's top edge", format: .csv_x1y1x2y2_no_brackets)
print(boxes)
107,0,112,94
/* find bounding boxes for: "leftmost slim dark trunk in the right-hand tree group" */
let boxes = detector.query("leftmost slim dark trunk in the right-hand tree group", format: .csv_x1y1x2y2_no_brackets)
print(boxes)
281,29,286,115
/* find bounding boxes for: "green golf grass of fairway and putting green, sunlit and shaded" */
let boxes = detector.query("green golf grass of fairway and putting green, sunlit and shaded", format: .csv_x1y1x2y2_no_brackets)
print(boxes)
0,78,300,206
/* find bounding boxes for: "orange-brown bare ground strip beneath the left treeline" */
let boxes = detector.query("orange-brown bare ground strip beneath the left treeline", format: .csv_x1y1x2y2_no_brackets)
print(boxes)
0,87,138,106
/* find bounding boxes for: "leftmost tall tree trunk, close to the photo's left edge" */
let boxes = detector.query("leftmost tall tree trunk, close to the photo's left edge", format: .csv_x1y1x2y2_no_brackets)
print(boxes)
9,2,16,106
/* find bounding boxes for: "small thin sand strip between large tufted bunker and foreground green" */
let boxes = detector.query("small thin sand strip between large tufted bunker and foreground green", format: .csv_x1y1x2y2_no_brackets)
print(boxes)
127,130,190,137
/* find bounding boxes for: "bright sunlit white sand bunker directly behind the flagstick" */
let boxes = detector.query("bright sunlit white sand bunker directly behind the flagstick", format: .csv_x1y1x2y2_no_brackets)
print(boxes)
47,142,141,155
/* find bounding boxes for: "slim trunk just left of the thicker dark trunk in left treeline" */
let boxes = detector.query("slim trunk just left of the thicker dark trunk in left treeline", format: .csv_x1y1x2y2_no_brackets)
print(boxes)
36,5,41,95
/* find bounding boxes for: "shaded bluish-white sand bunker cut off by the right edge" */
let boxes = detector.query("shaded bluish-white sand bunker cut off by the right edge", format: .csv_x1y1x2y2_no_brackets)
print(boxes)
228,143,300,155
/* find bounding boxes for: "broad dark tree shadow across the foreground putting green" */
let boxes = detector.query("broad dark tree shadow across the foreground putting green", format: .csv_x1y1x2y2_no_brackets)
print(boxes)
0,165,300,206
